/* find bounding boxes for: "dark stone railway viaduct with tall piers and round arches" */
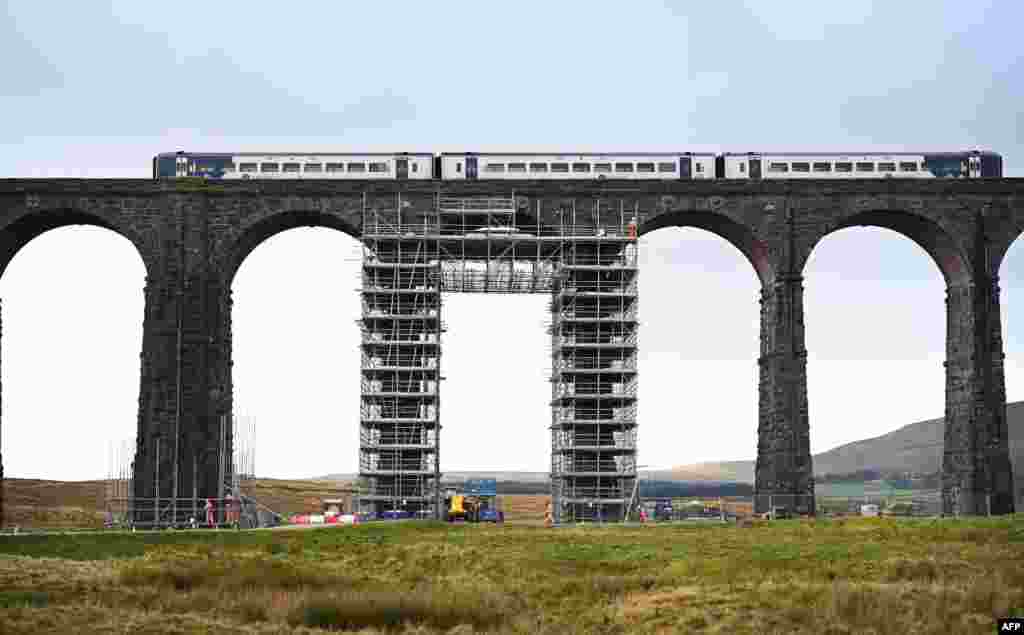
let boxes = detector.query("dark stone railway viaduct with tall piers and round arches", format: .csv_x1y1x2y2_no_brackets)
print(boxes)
0,179,1024,514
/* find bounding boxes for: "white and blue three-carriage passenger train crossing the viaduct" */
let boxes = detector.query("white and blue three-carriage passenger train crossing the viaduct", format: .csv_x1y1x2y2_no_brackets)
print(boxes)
153,151,1002,181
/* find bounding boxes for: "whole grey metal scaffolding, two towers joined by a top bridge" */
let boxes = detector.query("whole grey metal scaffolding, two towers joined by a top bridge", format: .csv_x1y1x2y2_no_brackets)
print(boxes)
359,192,639,522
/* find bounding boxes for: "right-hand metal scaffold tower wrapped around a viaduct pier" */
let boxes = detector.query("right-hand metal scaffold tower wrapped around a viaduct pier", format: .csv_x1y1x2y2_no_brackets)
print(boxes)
551,202,638,522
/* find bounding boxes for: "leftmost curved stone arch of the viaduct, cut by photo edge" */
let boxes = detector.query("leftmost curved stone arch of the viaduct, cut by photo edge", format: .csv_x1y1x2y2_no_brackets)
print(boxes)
0,208,153,279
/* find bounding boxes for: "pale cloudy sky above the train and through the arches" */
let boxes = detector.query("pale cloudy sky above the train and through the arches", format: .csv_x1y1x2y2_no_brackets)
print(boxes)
0,0,1024,479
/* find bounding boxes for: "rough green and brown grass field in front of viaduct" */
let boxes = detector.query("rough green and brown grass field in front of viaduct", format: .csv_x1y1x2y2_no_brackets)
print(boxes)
0,514,1024,634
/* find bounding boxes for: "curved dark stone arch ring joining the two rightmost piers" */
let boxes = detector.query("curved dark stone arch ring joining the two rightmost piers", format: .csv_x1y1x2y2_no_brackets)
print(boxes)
800,209,973,288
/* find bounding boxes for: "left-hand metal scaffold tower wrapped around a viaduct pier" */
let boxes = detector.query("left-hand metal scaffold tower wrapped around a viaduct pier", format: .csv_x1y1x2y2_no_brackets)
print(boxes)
358,195,442,517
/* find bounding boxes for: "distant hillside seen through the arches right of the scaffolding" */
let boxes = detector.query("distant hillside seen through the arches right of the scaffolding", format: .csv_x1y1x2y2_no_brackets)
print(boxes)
672,401,1024,483
